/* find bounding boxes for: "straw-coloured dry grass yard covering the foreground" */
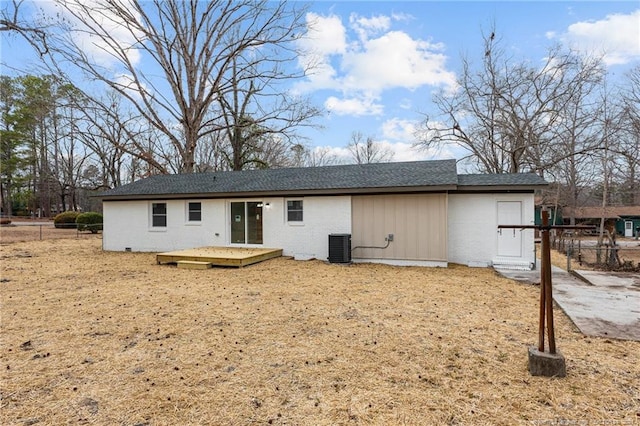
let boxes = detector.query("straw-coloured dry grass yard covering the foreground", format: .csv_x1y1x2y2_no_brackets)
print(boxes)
0,234,640,426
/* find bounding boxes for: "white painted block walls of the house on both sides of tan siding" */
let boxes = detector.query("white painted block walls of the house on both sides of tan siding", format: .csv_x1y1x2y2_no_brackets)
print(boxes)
103,194,535,266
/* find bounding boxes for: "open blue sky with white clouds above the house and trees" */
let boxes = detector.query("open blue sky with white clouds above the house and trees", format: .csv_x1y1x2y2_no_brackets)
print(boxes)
0,0,640,161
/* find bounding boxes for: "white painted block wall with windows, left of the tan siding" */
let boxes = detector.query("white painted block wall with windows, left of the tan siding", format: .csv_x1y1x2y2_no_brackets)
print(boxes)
103,196,351,260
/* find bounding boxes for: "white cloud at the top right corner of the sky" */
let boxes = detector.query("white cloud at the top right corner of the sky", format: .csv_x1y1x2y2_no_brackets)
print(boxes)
547,9,640,65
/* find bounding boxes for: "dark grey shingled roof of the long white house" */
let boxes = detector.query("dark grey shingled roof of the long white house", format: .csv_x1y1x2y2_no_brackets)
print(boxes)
98,160,546,200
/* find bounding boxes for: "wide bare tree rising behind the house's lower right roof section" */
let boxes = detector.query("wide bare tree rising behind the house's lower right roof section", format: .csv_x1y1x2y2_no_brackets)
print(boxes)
420,30,602,174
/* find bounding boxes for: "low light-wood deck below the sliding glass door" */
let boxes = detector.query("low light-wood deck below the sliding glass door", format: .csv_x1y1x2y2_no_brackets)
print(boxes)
156,247,282,268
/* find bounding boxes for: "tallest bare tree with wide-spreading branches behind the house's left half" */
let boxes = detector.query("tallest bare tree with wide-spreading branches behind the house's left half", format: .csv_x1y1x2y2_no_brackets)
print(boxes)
45,0,316,173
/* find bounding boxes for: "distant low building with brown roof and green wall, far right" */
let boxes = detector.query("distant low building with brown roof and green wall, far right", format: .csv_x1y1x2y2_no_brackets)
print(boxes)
563,206,640,237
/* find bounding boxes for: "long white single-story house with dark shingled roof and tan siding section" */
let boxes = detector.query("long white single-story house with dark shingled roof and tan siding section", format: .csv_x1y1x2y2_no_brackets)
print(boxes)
100,160,547,268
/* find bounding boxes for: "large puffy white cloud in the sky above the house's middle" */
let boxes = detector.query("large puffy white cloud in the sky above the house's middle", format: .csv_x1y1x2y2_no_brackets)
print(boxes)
295,13,456,115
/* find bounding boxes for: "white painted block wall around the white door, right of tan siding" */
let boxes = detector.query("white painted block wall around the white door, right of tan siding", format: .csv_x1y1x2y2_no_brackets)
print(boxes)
448,194,535,267
